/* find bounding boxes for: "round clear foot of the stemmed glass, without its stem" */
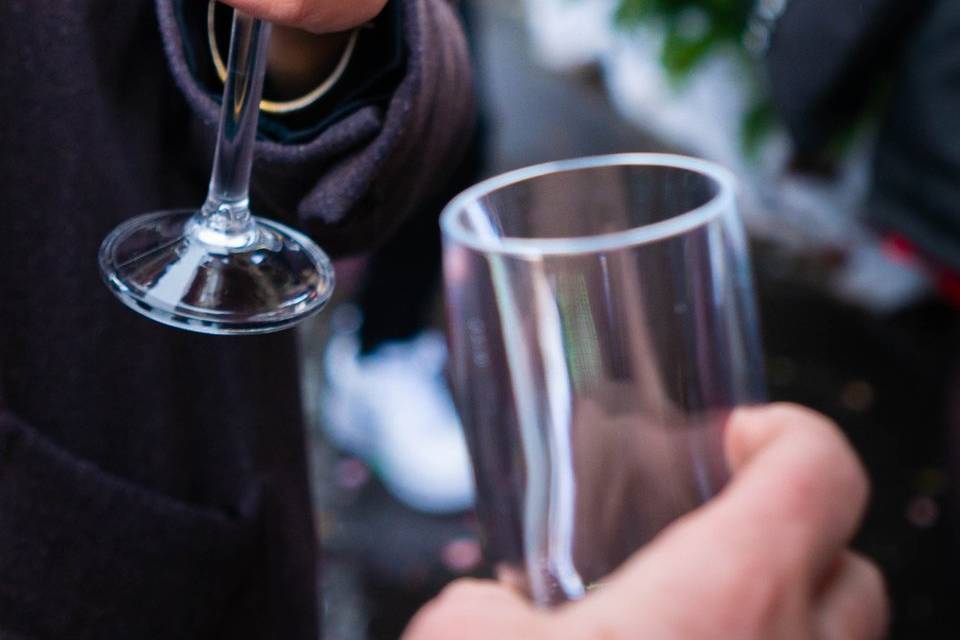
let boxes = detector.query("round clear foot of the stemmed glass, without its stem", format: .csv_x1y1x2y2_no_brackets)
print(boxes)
100,210,334,335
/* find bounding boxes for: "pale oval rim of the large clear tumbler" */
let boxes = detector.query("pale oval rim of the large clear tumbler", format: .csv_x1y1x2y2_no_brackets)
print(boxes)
440,153,736,257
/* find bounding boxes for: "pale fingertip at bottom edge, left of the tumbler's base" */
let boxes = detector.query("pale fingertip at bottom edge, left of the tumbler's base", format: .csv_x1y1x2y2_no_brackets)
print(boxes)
403,580,555,640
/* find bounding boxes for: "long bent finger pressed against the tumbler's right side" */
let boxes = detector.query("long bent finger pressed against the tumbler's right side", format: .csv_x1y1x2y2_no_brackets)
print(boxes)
556,405,867,638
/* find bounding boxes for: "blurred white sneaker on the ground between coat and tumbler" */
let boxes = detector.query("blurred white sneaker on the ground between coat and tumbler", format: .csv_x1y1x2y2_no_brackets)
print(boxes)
321,318,473,513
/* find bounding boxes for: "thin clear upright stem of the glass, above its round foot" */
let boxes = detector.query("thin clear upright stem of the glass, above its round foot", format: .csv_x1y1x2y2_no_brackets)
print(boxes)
200,11,270,234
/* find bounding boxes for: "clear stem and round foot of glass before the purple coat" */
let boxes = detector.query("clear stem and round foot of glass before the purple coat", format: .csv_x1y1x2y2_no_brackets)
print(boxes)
99,11,334,334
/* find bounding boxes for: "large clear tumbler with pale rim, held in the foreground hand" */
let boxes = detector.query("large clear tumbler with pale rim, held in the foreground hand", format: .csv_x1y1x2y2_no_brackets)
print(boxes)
441,154,764,606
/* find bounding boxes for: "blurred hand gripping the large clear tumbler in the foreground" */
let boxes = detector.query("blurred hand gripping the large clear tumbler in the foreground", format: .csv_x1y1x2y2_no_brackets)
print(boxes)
404,405,887,640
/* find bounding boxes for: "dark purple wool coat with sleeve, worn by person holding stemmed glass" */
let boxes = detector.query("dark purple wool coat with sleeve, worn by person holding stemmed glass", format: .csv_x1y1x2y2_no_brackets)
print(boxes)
0,0,472,640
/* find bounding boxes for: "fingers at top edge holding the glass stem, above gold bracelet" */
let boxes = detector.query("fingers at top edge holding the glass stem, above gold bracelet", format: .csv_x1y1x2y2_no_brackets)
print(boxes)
224,0,386,33
